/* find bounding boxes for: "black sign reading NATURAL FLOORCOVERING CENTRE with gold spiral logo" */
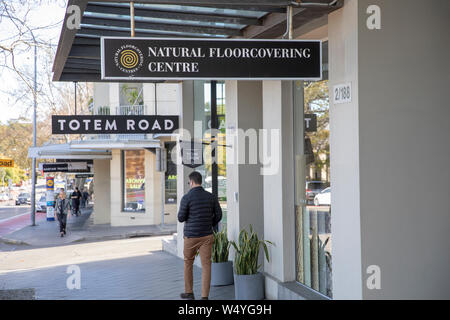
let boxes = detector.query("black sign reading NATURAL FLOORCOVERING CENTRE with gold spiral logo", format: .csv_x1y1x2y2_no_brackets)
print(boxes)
101,37,322,81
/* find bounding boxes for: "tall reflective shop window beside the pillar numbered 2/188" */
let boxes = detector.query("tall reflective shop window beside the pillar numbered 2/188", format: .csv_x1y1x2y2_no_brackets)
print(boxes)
296,75,332,297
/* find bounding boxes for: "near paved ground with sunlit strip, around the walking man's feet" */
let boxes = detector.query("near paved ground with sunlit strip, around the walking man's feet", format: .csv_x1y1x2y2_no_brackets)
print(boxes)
0,236,234,300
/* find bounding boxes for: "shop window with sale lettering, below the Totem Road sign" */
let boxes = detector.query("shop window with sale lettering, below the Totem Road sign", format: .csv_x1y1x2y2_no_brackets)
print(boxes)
122,150,145,212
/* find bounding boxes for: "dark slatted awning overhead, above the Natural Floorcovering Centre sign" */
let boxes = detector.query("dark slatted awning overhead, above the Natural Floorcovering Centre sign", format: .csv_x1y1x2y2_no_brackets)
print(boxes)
53,0,342,82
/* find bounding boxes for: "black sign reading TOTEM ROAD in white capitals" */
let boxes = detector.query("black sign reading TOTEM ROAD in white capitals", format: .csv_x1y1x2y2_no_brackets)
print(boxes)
52,115,178,134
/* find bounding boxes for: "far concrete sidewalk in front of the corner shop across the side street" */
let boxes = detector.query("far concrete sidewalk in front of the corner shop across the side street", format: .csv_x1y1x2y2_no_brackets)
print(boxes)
0,208,176,247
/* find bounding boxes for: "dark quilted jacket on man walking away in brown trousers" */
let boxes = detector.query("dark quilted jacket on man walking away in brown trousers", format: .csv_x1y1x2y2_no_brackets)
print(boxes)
178,187,222,238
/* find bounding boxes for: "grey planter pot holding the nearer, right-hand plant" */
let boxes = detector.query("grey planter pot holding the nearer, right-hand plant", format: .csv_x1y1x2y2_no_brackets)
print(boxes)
234,272,264,300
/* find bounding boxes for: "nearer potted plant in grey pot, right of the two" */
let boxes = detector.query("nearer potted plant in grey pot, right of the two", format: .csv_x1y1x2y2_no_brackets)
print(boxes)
231,225,272,300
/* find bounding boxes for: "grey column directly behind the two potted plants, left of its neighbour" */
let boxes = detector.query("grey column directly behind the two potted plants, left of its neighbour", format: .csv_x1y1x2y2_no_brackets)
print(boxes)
225,80,264,245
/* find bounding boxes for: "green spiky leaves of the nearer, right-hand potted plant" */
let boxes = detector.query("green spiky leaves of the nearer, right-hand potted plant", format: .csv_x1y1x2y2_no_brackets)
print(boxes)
231,225,272,275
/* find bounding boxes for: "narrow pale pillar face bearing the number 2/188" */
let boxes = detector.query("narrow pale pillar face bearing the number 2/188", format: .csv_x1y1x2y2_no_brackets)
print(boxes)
328,0,362,299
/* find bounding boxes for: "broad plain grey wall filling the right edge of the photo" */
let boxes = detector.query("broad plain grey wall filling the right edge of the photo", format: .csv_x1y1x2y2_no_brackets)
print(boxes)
356,0,450,299
